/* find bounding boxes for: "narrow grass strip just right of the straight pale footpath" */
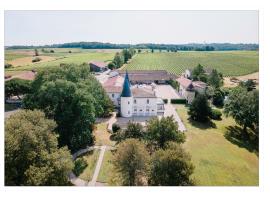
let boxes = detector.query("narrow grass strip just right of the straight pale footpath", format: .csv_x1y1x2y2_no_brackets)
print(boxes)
97,150,113,183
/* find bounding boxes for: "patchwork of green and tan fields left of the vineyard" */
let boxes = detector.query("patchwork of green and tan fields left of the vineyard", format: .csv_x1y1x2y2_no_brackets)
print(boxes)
5,48,115,73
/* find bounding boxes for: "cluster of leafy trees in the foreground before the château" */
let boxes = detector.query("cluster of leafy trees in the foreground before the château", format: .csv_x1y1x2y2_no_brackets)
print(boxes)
109,117,194,186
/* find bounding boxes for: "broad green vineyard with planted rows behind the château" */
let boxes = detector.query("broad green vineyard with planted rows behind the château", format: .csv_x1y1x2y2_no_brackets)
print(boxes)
124,51,259,76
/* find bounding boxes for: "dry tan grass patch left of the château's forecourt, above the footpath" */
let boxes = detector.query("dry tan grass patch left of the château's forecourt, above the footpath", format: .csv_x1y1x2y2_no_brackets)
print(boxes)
94,122,115,146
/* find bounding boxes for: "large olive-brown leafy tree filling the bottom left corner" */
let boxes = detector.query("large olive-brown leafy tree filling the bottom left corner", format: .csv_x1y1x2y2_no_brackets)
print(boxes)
5,110,73,186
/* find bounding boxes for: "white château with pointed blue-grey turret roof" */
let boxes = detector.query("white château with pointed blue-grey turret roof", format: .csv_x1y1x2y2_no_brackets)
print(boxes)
104,72,164,117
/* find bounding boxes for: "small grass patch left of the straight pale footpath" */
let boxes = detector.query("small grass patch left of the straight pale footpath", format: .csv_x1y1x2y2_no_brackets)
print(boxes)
76,149,100,181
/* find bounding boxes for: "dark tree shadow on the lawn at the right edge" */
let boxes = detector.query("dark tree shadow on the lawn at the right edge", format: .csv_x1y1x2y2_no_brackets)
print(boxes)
224,126,259,156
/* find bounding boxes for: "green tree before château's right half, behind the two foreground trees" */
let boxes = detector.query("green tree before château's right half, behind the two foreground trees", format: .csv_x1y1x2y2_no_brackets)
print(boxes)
145,116,185,149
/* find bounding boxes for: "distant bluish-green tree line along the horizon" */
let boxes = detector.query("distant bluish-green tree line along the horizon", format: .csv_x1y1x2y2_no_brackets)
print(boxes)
6,42,259,51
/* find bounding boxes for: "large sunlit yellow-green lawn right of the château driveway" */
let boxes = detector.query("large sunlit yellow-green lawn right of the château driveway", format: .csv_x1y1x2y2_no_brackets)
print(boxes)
175,105,259,186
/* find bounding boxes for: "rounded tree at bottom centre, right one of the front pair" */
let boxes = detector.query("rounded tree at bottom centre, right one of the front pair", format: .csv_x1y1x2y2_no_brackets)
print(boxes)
148,142,194,186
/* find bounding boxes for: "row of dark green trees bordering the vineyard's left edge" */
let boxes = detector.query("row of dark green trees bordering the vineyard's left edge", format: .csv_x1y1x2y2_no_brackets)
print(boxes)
108,48,136,69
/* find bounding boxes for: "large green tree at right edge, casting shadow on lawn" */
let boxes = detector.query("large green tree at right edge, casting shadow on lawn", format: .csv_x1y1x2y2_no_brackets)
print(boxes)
224,87,259,133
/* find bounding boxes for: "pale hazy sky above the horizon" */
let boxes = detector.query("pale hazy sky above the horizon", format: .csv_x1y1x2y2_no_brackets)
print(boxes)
5,11,258,46
